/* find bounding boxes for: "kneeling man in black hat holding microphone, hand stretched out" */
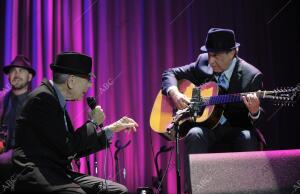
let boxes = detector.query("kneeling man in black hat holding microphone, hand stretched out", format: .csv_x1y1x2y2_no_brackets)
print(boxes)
13,52,138,193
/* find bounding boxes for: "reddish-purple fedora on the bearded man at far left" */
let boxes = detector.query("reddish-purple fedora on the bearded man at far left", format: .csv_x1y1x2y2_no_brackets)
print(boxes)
3,55,35,76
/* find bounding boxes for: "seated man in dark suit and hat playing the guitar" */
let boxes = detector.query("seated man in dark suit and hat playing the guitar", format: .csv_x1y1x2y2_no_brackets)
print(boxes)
162,28,263,193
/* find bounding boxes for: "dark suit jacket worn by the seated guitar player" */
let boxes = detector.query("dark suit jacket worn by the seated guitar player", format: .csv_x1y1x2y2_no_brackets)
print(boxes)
162,53,263,129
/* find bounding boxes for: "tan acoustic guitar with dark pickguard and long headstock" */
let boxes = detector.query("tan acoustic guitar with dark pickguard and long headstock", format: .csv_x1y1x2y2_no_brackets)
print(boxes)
150,80,300,141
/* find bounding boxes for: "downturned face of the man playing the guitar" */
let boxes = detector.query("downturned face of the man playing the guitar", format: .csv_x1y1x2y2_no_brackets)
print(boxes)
208,50,236,73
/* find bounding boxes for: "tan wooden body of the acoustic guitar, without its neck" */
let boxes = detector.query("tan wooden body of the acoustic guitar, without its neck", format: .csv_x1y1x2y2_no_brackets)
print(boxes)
150,80,223,140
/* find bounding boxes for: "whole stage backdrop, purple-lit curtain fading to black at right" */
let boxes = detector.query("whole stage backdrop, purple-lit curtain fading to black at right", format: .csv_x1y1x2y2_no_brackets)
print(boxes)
0,0,300,193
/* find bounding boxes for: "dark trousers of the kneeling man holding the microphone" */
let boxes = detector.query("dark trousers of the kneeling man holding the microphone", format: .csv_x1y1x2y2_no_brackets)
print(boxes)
14,167,128,194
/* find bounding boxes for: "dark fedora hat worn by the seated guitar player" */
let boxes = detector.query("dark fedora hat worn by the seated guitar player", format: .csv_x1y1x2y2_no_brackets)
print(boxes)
200,28,240,52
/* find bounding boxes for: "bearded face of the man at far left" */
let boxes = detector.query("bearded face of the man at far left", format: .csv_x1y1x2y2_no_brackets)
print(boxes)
8,67,32,90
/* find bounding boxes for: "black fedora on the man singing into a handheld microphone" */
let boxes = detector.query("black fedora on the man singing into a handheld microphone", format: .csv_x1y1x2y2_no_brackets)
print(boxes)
50,52,94,76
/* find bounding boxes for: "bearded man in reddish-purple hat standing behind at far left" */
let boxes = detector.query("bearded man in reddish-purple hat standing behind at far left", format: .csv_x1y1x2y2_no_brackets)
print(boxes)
0,55,35,151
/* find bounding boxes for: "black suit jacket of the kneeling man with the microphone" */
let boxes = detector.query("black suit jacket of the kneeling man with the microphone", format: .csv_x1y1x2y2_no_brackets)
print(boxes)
13,80,107,169
